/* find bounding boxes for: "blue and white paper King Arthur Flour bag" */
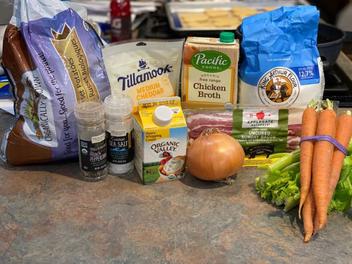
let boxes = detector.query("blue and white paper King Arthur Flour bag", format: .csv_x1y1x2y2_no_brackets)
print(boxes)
239,6,324,107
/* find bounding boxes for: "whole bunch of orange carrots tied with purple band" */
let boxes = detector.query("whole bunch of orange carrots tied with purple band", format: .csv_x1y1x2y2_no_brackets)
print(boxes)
298,100,352,242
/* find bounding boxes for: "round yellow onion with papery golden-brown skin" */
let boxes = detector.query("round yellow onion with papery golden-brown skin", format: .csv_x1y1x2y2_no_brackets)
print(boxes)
186,130,245,181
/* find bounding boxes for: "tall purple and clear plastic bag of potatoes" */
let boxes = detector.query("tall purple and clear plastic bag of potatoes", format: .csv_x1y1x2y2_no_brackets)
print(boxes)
1,0,110,165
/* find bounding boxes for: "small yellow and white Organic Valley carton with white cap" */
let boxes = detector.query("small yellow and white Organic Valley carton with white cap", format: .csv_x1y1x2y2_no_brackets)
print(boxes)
134,97,188,184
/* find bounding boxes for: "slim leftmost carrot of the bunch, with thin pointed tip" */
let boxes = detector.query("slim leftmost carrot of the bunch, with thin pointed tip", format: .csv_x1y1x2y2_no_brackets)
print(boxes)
298,102,318,219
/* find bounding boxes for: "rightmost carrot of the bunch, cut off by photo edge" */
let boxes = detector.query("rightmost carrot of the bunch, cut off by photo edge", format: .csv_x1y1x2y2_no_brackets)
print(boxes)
329,111,352,204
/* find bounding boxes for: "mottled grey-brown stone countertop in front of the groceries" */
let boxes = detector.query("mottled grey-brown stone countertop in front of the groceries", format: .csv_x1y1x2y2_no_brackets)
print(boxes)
0,111,352,264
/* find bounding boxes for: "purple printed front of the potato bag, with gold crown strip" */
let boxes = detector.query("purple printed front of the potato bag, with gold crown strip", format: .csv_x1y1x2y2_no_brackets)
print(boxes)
20,9,110,160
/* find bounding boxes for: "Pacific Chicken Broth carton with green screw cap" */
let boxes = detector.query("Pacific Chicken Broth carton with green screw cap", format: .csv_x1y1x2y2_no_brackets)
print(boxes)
182,32,239,108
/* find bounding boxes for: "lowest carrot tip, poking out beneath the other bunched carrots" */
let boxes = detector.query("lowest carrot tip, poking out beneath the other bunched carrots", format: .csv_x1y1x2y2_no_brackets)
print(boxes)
302,188,315,243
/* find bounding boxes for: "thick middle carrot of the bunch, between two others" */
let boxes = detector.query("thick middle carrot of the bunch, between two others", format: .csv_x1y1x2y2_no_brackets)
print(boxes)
312,100,336,232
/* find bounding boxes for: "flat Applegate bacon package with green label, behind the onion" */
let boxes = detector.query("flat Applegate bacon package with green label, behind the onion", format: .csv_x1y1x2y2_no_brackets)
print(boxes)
184,107,303,166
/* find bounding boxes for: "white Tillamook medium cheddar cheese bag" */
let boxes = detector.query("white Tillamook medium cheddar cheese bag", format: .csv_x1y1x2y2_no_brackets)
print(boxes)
103,40,183,112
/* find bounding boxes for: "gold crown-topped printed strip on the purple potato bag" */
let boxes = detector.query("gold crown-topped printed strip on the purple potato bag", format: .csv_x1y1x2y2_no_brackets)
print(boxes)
51,24,99,102
